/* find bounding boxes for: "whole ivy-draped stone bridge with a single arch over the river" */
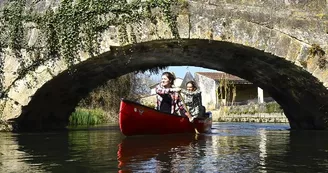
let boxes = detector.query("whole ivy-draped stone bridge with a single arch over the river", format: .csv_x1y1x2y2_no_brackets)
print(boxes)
0,0,328,131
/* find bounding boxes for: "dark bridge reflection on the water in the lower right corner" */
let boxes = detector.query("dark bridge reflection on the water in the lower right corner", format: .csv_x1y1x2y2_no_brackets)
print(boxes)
266,131,328,172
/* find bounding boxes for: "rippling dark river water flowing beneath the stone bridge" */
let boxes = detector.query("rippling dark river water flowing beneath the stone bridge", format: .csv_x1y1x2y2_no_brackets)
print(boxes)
0,123,328,173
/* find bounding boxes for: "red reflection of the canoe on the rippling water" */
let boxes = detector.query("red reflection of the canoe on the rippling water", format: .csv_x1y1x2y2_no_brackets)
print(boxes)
117,134,206,172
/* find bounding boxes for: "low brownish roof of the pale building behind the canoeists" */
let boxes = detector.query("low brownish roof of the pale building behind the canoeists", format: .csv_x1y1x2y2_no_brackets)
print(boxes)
196,72,251,84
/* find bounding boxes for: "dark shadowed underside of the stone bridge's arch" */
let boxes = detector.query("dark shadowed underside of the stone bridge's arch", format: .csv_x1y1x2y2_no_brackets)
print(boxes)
11,40,328,129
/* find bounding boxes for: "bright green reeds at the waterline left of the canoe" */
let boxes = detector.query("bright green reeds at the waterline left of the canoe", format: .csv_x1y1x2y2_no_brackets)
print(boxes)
69,108,107,126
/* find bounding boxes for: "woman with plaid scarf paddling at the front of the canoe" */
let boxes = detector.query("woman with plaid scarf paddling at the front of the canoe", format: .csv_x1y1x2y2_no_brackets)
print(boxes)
156,72,193,121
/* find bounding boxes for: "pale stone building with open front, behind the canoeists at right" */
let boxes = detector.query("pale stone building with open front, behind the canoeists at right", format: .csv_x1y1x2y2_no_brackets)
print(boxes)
195,72,270,110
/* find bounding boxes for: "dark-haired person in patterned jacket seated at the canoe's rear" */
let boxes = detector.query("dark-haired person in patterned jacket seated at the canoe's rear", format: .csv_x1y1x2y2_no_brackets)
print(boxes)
181,81,205,122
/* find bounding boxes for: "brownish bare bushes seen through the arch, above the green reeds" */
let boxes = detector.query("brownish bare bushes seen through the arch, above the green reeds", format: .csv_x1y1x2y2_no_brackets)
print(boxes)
79,71,159,122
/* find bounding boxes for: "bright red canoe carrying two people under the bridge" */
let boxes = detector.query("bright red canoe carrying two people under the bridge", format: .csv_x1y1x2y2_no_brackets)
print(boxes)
119,99,212,136
